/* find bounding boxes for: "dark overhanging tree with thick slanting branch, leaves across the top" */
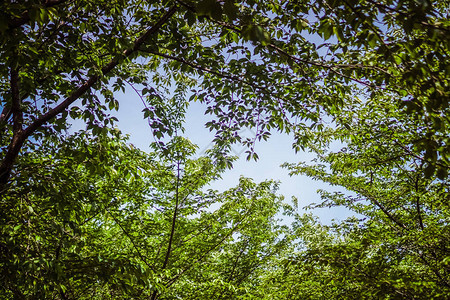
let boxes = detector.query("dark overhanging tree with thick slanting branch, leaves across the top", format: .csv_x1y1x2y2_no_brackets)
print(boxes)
0,0,449,184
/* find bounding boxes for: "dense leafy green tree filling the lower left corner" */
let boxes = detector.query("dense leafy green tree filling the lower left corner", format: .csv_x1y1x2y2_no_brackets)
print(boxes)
0,133,152,299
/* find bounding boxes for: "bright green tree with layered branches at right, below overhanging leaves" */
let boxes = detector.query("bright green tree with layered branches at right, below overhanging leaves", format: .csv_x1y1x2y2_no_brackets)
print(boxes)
278,93,450,299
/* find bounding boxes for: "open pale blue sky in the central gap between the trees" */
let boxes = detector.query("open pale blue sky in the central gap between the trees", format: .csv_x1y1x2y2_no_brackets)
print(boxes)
72,89,352,224
